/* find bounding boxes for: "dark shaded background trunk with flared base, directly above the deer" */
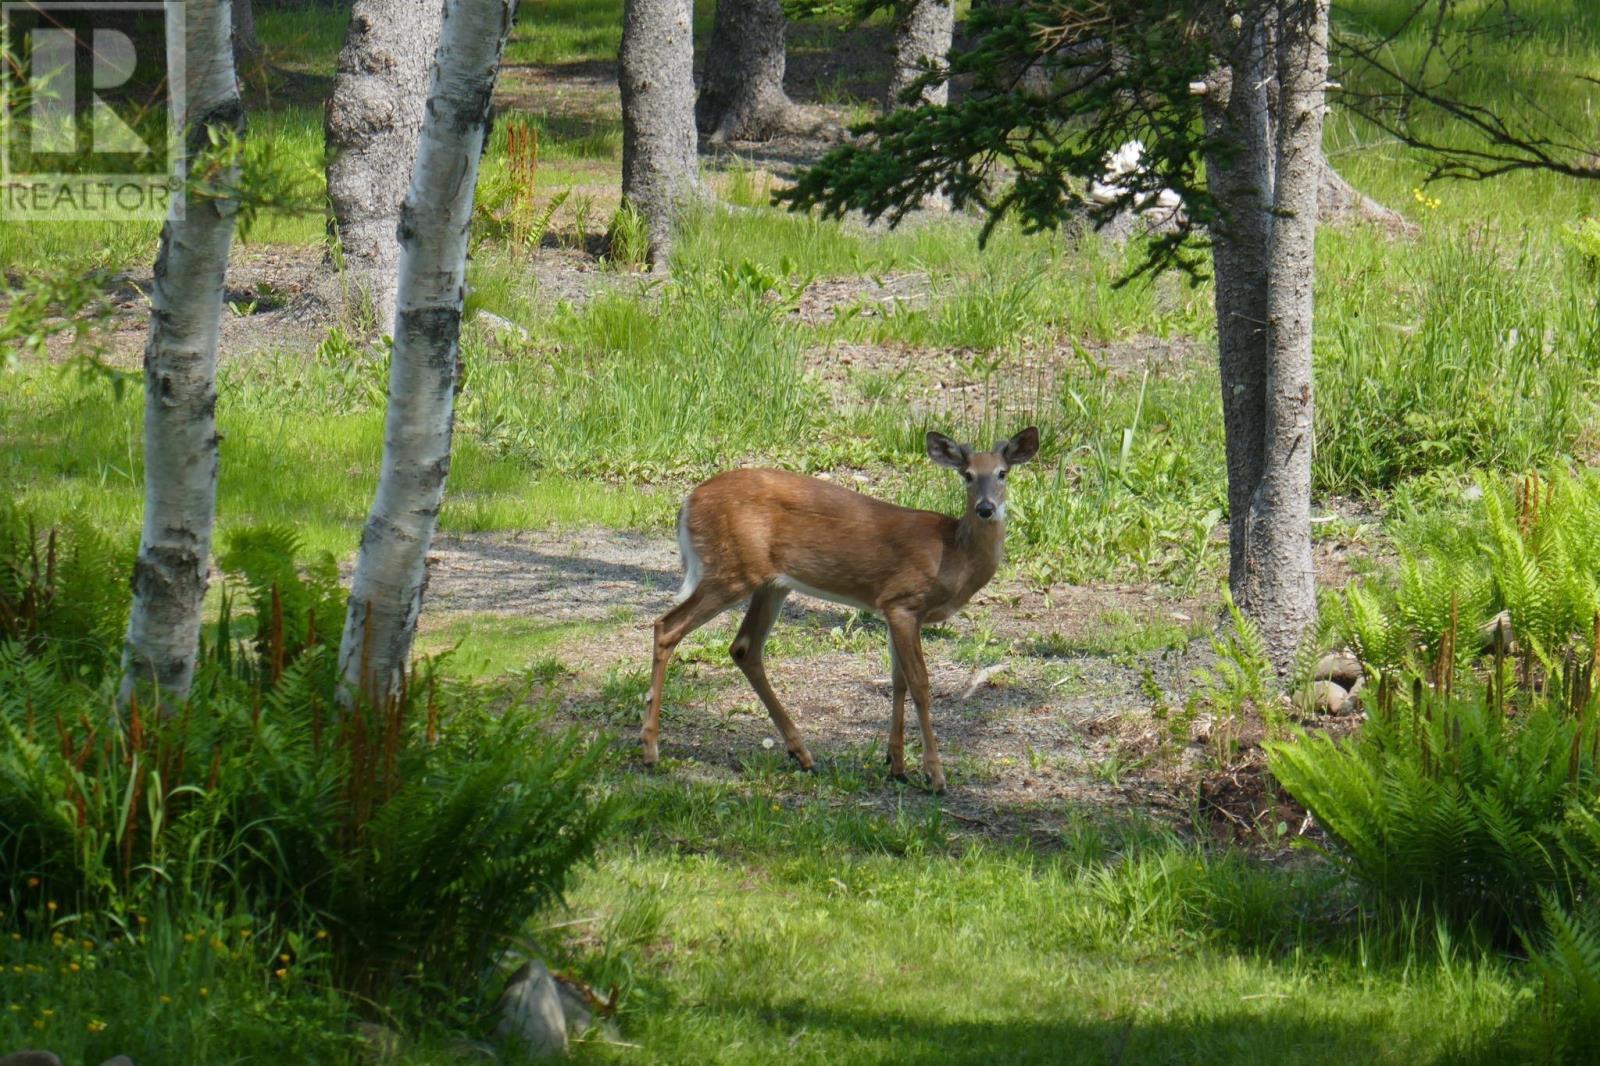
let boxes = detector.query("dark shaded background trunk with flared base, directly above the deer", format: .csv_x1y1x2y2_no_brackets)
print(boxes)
694,0,795,141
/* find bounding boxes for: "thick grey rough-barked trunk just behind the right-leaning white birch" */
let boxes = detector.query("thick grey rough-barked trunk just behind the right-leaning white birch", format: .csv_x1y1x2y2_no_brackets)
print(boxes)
325,0,440,335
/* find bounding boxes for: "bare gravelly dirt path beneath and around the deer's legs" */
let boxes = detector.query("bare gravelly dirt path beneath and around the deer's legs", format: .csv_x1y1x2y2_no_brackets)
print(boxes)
426,530,1210,834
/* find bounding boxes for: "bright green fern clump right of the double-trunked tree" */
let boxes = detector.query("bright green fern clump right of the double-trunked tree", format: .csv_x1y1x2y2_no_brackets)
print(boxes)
1269,475,1600,941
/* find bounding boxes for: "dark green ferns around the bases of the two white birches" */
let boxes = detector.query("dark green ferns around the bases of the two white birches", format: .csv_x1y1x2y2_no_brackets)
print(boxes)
0,518,608,996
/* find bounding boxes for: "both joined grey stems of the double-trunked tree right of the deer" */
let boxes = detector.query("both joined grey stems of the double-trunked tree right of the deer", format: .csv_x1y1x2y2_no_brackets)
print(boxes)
1203,0,1328,675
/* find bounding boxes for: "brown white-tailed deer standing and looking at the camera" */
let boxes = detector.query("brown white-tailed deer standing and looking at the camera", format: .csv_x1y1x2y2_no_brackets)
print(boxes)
640,426,1038,792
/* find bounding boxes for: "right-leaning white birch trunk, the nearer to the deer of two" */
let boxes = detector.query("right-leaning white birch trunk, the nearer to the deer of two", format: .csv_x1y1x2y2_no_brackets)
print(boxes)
339,0,515,703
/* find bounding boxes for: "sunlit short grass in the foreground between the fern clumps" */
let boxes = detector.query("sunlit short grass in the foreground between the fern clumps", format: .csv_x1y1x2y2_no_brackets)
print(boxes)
547,765,1520,1063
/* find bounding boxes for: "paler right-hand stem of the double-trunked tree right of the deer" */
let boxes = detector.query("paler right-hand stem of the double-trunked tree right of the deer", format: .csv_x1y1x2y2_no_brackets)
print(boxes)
1246,0,1328,674
